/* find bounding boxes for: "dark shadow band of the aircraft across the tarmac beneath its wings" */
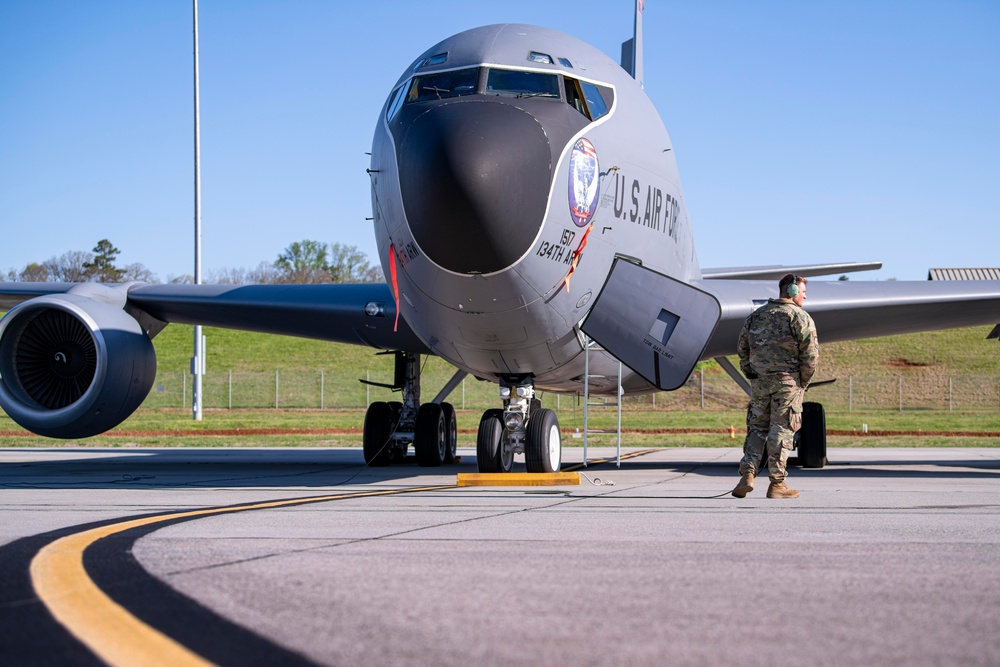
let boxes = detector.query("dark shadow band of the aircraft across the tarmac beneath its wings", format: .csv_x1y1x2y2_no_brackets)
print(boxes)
0,449,1000,489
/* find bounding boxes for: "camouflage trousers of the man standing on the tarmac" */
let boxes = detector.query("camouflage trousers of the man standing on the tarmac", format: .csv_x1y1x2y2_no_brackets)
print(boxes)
740,375,805,482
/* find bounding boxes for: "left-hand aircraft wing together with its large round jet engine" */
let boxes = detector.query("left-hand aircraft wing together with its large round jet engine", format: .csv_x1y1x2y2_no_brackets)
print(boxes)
0,283,429,438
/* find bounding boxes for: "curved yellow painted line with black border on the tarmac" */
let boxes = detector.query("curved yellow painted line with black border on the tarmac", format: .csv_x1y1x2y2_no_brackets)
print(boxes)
31,485,455,667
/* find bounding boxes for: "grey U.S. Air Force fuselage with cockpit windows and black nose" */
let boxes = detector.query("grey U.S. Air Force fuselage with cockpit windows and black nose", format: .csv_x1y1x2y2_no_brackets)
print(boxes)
371,24,700,391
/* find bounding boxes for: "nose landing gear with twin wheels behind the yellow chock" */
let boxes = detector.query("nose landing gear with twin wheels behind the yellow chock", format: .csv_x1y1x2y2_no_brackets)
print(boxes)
476,375,562,472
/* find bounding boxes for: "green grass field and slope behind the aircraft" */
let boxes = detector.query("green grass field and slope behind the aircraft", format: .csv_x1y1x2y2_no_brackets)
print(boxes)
0,325,1000,447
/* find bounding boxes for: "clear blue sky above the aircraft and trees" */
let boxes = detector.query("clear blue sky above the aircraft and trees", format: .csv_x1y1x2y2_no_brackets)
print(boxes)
0,0,1000,280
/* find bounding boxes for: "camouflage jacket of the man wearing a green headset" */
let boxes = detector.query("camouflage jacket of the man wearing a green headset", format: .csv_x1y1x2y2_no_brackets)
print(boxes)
737,299,819,387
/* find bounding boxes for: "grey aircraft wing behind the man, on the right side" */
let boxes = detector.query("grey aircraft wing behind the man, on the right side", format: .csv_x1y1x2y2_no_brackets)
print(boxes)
692,273,1000,359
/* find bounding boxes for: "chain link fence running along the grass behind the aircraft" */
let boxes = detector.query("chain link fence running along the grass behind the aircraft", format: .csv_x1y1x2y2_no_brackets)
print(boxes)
143,370,1000,412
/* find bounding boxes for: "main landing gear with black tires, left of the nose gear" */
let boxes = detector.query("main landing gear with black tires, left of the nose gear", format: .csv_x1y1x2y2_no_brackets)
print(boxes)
362,352,458,466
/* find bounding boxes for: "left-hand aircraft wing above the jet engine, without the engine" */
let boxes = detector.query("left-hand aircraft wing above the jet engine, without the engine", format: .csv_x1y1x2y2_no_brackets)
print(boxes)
0,283,430,354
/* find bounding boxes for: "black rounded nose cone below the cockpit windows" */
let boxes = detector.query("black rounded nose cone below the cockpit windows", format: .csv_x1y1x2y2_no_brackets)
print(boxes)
397,101,552,274
